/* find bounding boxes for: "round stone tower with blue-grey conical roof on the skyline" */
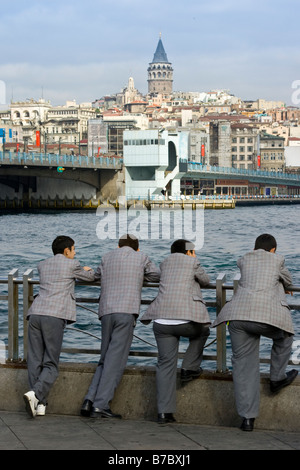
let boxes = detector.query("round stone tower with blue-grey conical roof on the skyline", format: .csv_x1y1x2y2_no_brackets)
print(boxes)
147,33,173,96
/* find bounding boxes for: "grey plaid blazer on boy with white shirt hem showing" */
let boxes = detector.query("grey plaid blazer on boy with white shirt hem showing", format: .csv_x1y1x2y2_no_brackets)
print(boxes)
141,253,210,323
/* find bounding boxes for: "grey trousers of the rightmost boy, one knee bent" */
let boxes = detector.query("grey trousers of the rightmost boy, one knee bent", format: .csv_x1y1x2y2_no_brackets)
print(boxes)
228,320,293,418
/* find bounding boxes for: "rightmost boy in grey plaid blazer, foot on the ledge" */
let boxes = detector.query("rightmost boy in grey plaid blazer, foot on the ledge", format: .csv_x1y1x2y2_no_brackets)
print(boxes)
213,234,298,431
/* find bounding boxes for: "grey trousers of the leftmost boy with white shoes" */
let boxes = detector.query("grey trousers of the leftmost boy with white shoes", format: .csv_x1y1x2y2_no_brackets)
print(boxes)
27,315,66,405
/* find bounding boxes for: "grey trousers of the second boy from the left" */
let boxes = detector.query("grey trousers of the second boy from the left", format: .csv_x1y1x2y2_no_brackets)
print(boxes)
85,313,135,410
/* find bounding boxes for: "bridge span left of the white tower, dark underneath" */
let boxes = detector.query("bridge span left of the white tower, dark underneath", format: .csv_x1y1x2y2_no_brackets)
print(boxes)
0,152,123,203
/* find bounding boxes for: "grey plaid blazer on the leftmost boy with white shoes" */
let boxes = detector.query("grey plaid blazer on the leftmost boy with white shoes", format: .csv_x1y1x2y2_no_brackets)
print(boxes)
27,254,95,323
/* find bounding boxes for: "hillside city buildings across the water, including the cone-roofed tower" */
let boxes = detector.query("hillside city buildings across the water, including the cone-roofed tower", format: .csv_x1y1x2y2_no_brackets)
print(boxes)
0,37,300,171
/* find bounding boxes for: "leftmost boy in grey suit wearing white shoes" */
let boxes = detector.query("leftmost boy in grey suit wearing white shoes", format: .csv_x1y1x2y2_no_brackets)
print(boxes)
24,236,94,417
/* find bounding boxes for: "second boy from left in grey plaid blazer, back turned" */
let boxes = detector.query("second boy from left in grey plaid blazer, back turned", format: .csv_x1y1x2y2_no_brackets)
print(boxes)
80,234,160,418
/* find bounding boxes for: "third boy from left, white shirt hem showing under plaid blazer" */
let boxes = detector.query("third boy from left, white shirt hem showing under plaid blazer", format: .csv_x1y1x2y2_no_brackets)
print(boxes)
141,239,211,424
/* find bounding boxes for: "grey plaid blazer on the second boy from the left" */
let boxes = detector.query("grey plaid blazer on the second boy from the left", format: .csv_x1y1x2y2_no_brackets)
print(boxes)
95,246,160,318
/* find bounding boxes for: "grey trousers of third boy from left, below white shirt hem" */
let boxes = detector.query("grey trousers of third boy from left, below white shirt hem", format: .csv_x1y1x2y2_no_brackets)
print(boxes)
153,322,209,413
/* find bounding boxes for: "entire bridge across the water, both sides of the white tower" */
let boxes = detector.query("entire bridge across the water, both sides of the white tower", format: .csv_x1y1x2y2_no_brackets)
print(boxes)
0,151,300,207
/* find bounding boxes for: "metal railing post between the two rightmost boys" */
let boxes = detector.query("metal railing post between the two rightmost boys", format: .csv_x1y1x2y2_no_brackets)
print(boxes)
216,273,226,372
